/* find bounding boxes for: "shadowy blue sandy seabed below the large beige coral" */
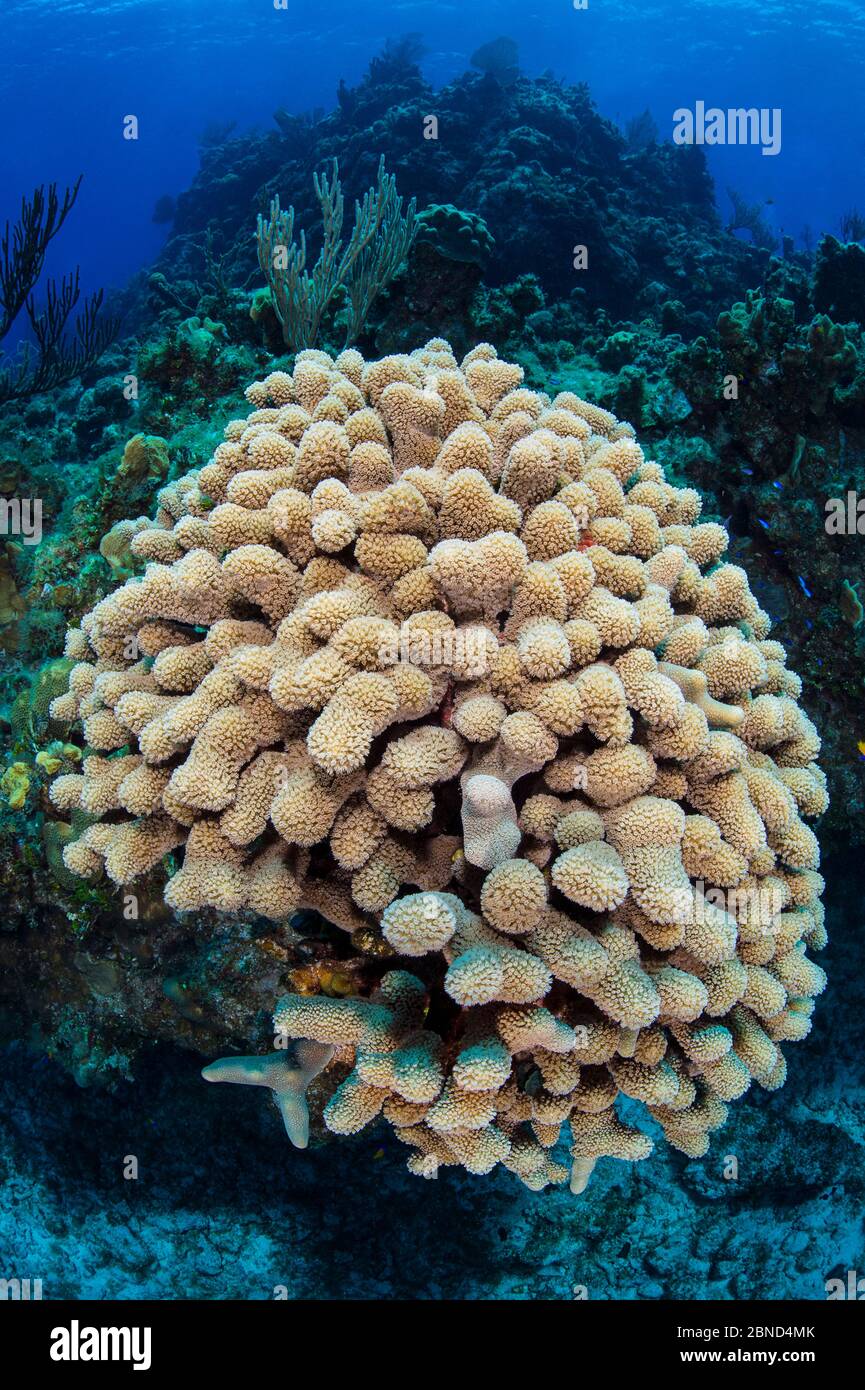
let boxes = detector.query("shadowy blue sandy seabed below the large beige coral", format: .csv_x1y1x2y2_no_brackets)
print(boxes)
0,859,865,1300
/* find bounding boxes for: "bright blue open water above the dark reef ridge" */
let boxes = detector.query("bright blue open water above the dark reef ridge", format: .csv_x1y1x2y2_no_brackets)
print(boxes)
0,0,865,309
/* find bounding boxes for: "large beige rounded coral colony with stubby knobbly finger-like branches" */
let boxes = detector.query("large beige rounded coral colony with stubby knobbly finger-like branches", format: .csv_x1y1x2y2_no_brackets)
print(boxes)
53,339,826,1191
